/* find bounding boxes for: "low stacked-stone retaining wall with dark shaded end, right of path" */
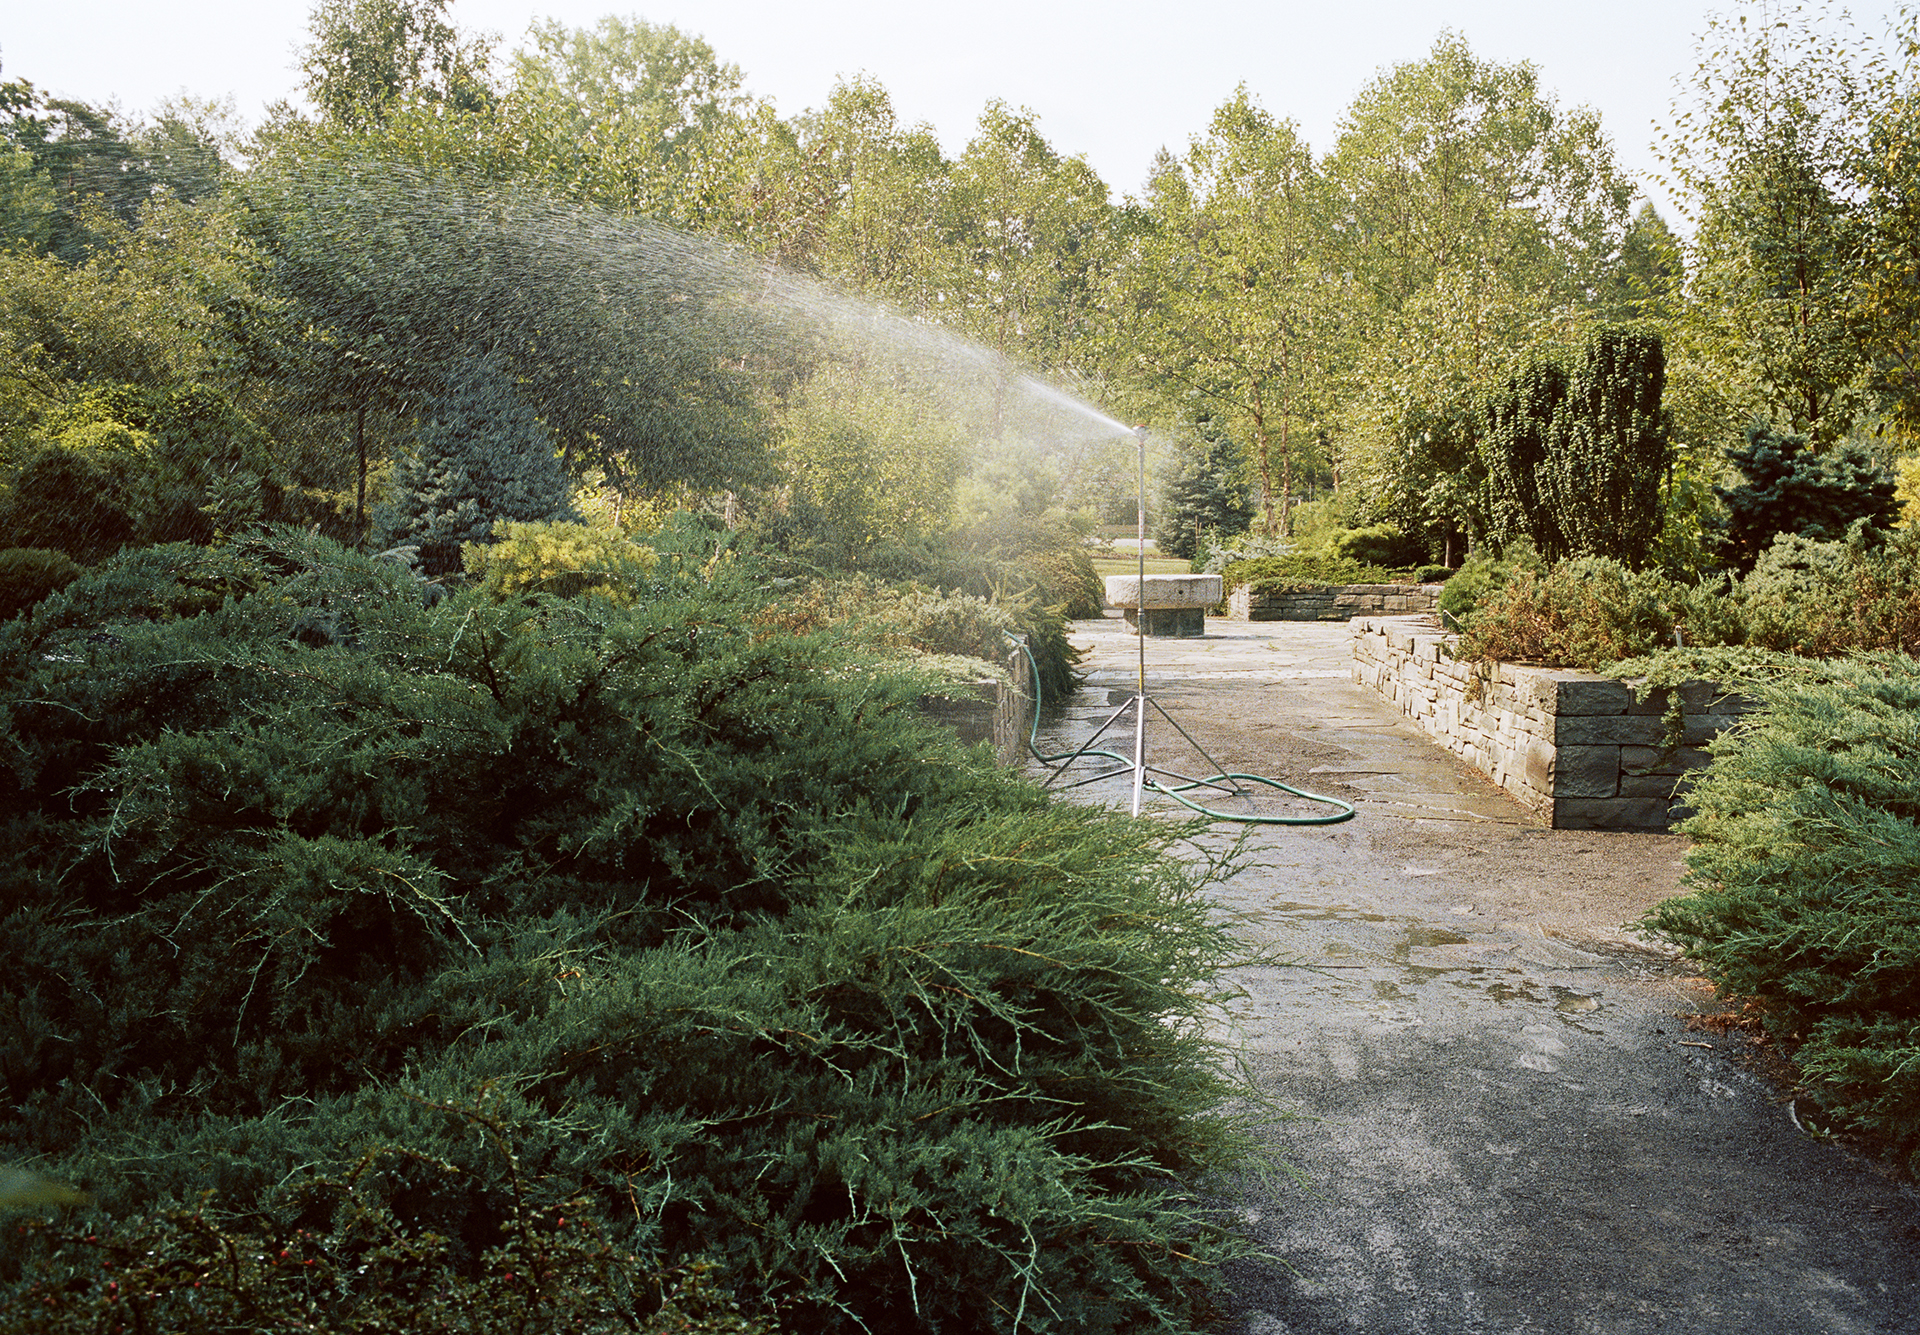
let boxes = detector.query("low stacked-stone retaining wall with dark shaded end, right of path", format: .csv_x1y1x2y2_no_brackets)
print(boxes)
1354,617,1745,830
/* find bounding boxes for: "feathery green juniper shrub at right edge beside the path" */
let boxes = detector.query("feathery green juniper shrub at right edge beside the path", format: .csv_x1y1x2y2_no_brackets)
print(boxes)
1647,653,1920,1168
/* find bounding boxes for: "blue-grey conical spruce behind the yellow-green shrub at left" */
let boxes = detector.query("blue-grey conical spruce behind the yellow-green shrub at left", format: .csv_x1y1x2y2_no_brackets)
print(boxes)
372,361,576,574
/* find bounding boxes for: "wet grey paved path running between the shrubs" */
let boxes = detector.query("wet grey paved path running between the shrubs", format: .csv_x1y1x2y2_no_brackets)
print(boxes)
1041,620,1920,1335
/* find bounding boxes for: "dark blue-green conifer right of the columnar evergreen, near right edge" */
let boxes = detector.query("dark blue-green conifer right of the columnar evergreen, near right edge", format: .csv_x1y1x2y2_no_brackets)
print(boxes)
1715,423,1899,570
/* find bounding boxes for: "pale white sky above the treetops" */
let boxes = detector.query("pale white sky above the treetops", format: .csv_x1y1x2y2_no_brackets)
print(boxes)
0,0,1895,223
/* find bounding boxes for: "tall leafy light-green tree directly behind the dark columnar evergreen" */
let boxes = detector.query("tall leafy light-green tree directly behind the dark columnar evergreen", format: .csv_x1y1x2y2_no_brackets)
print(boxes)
1327,35,1628,551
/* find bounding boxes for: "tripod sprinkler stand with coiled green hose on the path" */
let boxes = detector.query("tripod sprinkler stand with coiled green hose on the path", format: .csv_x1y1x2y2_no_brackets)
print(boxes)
1027,426,1356,826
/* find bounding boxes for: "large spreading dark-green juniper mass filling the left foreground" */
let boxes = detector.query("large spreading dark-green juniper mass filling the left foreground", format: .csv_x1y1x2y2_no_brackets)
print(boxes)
0,532,1244,1331
